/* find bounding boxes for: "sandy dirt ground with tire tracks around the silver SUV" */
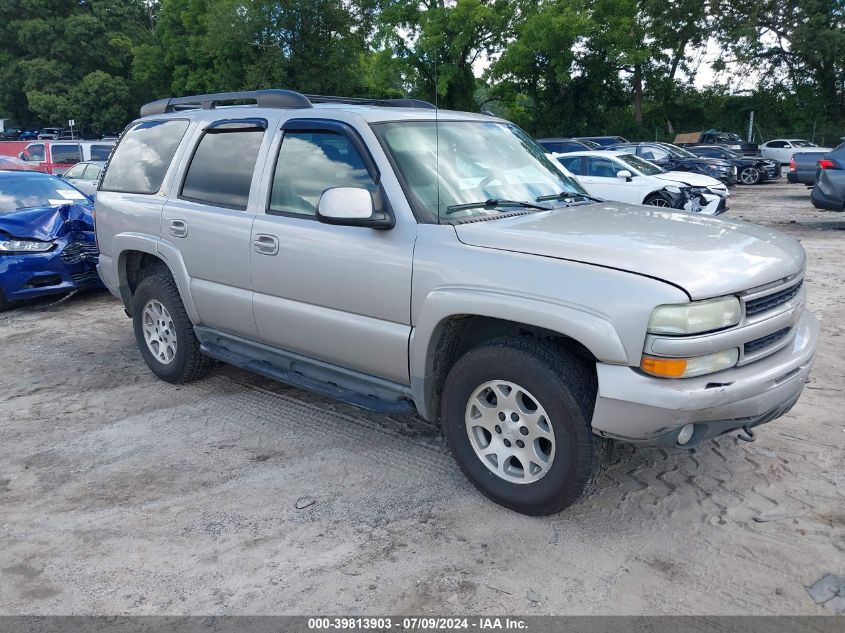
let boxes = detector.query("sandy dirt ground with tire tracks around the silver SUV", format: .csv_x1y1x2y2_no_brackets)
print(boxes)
0,182,845,615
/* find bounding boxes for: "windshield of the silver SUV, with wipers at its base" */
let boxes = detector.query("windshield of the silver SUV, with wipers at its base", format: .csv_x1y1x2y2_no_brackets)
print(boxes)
373,121,584,222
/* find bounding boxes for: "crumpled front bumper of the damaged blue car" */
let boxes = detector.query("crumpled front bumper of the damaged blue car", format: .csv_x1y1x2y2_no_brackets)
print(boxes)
0,231,101,301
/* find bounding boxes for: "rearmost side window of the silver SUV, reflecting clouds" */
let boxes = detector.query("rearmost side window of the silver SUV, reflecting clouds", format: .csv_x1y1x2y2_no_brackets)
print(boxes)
100,119,188,193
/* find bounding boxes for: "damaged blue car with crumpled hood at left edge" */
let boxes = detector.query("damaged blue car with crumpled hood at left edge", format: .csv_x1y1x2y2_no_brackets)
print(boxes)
0,171,101,310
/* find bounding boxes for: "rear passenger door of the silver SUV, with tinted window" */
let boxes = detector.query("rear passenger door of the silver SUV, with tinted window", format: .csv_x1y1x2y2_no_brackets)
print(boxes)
161,119,267,338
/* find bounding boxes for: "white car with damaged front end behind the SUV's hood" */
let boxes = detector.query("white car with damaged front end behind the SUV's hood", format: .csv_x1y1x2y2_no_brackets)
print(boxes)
553,151,730,215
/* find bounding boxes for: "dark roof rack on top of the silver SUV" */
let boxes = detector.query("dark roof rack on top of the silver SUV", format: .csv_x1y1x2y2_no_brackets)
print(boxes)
141,90,435,116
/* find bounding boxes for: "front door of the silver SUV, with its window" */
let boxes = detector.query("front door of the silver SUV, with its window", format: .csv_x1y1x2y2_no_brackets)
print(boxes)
252,119,416,384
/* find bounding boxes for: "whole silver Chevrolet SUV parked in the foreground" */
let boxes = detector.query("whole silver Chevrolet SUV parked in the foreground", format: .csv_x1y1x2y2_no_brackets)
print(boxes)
96,90,819,514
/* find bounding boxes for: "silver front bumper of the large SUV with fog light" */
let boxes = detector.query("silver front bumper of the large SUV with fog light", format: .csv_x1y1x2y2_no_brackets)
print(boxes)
592,310,819,448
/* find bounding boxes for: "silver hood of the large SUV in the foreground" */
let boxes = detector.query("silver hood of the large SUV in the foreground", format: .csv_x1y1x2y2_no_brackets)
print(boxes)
455,202,804,299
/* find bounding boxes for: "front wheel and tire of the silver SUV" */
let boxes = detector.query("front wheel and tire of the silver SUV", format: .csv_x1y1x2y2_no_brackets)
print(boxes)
441,337,605,515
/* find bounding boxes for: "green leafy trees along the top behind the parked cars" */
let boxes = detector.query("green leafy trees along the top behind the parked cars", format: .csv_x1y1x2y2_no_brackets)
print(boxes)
0,0,845,142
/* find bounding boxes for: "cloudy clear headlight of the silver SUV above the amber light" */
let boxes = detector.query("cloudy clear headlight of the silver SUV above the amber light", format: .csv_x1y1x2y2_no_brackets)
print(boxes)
648,297,742,335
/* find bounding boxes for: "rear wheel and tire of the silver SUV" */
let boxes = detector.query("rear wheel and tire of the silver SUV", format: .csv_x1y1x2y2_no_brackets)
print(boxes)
132,272,214,383
